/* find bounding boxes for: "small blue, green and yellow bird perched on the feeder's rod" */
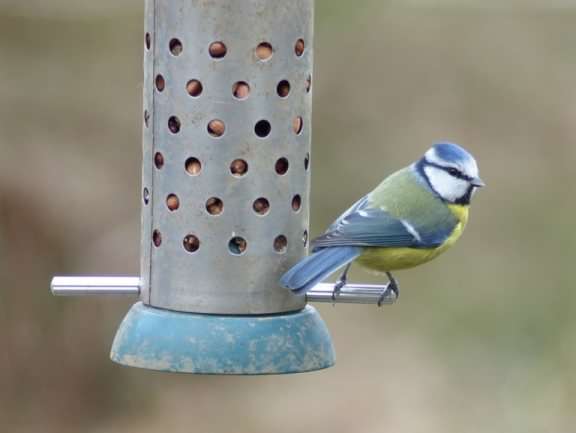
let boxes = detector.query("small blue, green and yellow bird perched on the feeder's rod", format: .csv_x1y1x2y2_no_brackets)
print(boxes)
280,142,485,306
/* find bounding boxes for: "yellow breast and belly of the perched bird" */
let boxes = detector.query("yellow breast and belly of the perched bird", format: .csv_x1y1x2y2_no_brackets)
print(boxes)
356,205,468,272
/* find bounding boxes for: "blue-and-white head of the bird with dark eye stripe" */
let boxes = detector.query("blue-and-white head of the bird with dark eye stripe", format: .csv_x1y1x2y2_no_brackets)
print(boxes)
417,143,484,205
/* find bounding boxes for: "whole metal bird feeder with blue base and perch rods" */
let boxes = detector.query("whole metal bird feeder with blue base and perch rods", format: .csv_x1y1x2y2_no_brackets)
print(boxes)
52,0,394,374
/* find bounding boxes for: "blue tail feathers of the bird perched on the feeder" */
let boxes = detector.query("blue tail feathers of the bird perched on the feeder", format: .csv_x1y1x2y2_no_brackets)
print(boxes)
280,247,361,294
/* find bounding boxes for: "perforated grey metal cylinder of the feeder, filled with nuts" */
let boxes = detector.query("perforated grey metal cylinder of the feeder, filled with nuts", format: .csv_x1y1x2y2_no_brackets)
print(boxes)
141,0,313,314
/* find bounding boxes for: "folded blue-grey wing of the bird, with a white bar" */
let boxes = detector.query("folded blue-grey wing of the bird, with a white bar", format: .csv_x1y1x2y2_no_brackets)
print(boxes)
313,197,457,250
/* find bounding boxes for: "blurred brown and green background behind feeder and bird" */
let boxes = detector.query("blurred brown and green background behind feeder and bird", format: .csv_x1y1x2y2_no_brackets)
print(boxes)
0,0,576,433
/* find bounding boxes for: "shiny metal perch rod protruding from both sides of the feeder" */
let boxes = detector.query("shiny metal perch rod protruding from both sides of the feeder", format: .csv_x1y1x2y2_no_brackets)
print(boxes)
50,277,396,304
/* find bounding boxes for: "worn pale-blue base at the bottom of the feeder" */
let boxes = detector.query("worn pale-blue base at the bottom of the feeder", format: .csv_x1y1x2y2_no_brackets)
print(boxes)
110,302,334,374
